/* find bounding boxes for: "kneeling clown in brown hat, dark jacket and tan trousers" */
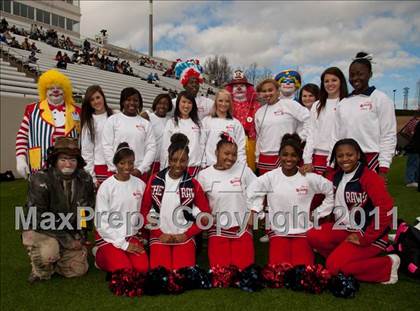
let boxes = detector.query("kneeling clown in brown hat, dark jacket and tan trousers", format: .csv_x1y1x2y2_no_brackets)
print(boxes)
22,137,95,284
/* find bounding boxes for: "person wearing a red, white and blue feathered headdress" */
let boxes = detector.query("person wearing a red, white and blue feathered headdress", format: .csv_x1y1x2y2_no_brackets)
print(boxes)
172,61,214,120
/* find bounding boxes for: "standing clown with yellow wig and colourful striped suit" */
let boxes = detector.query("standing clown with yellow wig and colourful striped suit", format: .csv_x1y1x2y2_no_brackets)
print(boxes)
16,69,80,179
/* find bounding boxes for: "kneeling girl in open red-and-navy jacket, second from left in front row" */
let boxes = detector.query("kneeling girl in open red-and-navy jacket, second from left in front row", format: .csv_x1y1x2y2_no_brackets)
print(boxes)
141,133,210,270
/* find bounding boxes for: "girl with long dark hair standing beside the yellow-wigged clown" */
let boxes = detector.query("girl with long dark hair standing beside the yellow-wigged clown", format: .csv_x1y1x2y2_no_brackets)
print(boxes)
80,85,113,187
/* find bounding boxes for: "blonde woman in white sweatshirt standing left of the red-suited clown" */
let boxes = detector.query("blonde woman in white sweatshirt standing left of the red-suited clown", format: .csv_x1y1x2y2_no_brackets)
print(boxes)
202,90,246,166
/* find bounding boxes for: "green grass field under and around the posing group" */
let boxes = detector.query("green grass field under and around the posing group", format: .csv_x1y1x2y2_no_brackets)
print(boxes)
0,157,420,311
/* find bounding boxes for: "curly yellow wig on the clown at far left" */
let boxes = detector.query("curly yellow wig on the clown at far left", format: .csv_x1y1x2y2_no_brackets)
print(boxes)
38,69,74,104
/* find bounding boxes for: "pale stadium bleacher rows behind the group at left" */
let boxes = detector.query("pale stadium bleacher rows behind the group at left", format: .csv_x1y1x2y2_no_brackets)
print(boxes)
0,34,213,108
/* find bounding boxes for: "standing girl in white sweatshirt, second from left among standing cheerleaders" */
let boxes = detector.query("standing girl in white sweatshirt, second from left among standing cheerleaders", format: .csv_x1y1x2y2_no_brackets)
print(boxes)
102,87,156,181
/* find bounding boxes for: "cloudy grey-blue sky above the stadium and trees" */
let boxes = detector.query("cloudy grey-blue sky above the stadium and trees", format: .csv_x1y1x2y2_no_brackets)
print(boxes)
80,0,420,107
